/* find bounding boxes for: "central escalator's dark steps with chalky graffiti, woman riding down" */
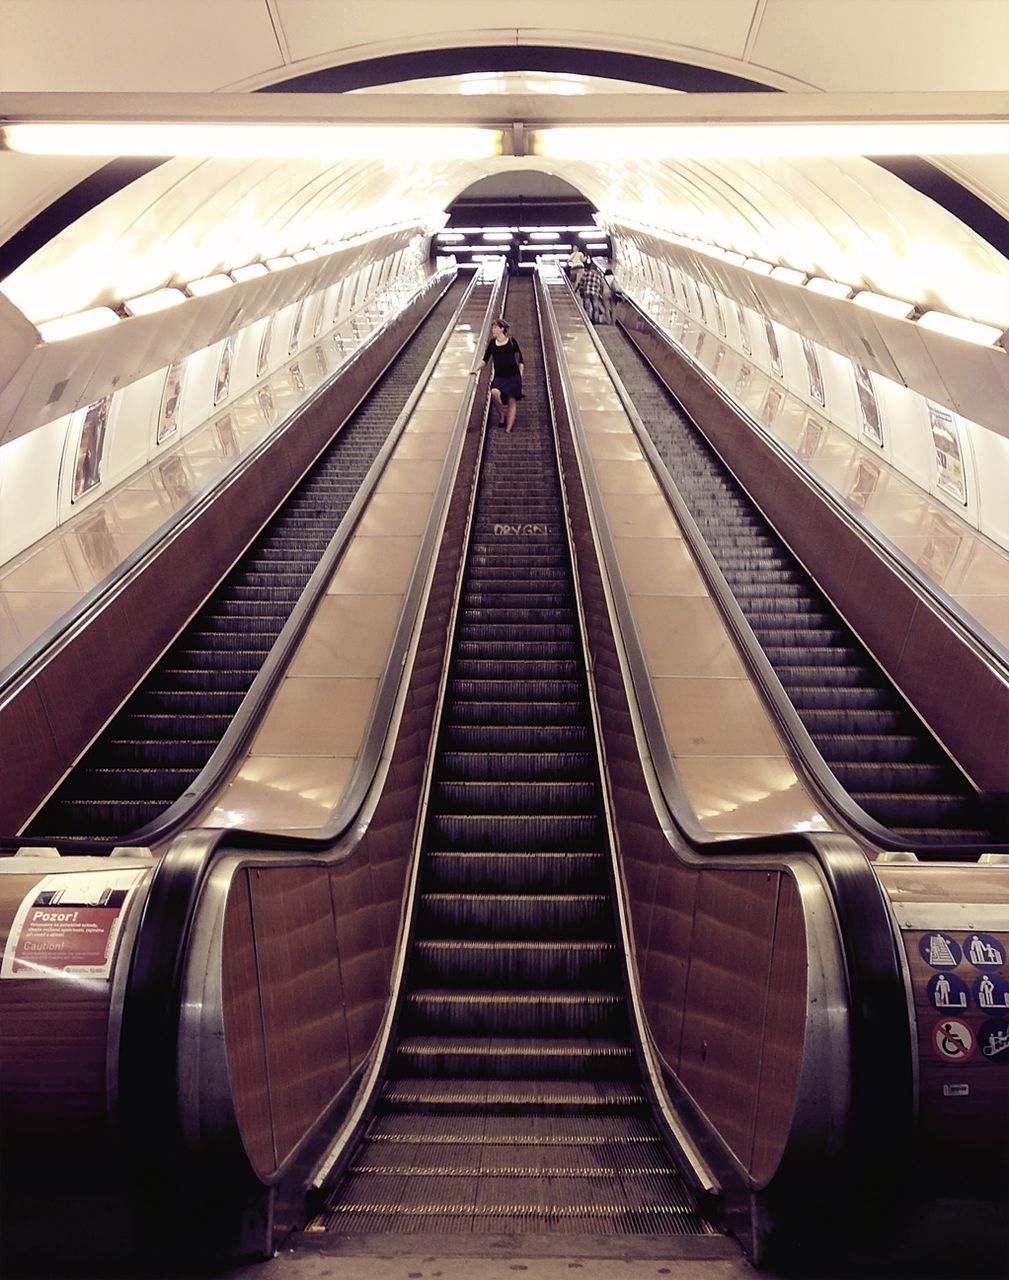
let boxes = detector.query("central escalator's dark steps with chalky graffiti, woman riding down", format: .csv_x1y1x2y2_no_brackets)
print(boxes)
311,282,713,1235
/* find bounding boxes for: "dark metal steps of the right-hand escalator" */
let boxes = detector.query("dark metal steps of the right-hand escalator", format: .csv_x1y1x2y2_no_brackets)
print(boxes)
597,325,1006,856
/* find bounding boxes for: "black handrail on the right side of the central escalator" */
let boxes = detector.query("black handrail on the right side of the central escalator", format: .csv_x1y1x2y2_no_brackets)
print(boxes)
543,264,914,1203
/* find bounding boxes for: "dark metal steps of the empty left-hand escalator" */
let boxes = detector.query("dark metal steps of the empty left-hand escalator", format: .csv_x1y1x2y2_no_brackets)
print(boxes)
24,282,466,840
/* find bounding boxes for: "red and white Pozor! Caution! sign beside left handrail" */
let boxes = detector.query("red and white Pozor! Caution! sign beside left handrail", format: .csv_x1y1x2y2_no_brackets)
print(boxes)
0,868,146,978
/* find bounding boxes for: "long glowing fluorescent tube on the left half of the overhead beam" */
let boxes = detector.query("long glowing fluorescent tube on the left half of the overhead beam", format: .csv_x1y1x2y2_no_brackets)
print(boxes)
0,120,502,161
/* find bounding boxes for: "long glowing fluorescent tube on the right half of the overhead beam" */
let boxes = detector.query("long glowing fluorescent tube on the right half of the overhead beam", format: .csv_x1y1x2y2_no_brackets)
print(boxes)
529,120,1009,160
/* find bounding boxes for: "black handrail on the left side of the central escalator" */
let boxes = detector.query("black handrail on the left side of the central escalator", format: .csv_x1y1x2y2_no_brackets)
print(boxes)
115,267,502,1204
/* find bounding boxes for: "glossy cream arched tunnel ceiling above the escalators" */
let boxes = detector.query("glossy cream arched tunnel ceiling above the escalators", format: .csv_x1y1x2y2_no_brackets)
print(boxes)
0,0,1009,340
